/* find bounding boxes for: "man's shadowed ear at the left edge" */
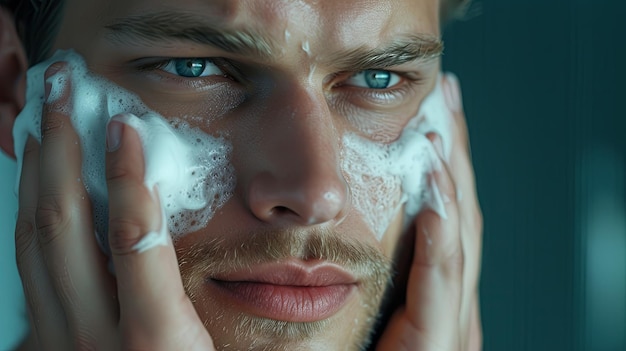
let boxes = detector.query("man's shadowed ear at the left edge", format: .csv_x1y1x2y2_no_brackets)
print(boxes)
0,6,28,158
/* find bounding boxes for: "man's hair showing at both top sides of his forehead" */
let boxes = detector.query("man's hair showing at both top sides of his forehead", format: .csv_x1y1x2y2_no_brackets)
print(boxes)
0,0,471,65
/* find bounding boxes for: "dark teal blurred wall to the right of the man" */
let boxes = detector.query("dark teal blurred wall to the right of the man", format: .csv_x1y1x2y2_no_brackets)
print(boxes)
444,0,626,351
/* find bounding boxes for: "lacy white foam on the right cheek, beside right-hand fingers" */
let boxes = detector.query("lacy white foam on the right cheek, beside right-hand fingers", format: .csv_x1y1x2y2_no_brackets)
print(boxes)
342,77,452,240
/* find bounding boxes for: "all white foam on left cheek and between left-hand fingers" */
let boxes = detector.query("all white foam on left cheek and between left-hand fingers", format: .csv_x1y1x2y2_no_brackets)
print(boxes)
13,51,236,252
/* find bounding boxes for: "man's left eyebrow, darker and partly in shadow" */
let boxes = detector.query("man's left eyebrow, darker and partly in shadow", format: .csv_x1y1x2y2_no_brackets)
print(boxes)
104,12,274,58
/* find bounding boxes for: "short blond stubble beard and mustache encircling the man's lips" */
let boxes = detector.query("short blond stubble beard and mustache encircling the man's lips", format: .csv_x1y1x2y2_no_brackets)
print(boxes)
177,230,392,351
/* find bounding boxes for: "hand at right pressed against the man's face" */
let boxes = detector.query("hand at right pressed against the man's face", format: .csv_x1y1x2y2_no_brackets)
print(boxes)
377,75,482,351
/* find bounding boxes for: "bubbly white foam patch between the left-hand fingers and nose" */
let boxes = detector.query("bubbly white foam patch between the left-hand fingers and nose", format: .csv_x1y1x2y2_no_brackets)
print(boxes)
151,119,236,237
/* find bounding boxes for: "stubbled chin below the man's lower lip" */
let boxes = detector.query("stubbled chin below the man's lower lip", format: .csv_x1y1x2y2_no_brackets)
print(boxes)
188,283,382,351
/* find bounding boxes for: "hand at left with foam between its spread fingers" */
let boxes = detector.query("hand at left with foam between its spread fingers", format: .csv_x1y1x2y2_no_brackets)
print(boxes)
15,63,214,350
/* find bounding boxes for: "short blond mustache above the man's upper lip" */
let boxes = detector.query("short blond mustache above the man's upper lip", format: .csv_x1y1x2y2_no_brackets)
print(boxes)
176,228,392,295
